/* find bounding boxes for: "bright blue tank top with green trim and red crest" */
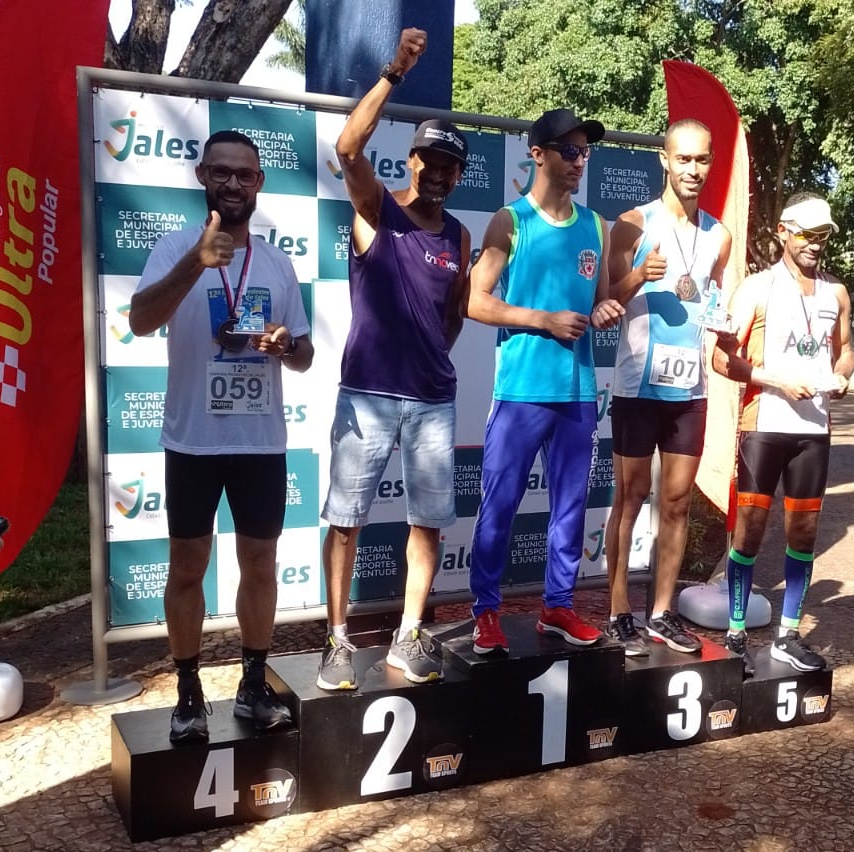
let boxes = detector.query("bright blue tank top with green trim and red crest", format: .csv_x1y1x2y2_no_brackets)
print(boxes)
493,196,602,402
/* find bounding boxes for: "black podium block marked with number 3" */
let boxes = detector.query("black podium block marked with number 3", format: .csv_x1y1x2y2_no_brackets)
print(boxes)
623,640,743,753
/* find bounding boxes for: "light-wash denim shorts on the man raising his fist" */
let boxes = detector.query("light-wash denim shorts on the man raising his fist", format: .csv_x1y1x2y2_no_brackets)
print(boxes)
321,389,456,528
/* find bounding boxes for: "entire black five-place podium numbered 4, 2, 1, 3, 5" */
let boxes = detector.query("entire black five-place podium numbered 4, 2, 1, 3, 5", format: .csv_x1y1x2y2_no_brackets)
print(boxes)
112,614,833,840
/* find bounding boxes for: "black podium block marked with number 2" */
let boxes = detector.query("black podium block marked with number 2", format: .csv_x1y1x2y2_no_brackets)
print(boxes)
267,646,472,811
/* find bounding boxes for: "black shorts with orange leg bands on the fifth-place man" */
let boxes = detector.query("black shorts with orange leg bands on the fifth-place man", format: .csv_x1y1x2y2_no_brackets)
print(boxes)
738,432,830,511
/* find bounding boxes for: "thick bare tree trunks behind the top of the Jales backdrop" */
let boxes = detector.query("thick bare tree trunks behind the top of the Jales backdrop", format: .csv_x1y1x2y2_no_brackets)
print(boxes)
104,0,292,83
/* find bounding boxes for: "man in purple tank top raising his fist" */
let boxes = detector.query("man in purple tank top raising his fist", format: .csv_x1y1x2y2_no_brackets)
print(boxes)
317,29,471,689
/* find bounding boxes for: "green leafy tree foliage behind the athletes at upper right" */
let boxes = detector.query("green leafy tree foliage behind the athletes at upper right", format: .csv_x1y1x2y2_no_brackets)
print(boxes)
453,0,854,280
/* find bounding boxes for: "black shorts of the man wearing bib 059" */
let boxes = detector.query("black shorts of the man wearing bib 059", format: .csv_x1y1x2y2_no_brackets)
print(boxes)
166,450,288,539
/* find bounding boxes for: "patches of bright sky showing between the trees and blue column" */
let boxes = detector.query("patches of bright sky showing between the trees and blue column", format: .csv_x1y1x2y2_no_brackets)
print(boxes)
110,0,478,92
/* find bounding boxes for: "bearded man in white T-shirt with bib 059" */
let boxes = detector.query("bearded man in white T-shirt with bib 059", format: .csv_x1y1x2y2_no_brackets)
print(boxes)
134,130,314,743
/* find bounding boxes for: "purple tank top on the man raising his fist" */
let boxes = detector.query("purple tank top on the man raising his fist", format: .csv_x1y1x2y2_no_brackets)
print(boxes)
341,190,462,402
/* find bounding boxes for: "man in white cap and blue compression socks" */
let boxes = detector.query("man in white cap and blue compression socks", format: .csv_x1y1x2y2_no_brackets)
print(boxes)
713,193,854,675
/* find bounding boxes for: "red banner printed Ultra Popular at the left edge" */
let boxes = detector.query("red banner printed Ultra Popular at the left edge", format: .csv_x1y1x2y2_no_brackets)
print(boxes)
0,0,109,570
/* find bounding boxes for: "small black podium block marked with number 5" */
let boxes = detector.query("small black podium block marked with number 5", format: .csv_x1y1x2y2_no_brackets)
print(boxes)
741,647,833,734
